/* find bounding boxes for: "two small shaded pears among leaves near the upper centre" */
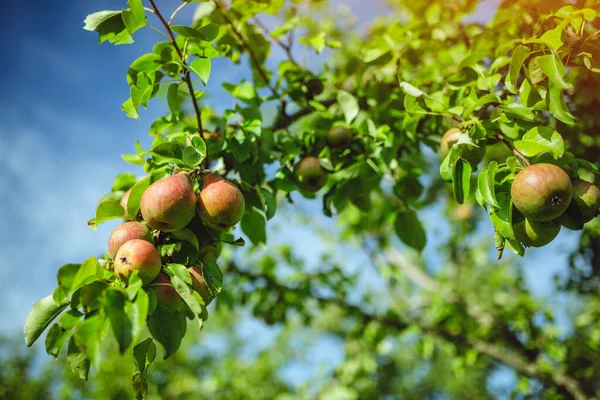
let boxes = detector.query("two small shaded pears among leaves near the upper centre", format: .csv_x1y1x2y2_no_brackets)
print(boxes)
294,125,353,193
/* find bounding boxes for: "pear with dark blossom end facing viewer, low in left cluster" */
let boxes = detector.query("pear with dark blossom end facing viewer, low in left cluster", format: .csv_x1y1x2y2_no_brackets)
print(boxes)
114,239,161,284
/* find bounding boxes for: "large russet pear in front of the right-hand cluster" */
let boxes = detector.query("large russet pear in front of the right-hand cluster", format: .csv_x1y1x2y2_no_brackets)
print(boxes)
510,163,573,221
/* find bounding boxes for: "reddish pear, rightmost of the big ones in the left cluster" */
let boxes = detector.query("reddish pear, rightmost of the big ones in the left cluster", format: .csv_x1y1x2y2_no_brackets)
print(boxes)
198,173,246,229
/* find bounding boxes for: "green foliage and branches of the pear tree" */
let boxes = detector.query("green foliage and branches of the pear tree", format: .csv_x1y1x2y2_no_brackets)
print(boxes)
25,0,600,399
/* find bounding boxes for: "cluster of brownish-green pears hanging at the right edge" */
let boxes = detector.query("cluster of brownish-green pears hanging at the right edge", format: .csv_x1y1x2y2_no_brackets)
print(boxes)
510,163,600,247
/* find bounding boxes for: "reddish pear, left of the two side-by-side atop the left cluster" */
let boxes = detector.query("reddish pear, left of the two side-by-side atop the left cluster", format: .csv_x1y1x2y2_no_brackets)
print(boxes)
140,172,196,232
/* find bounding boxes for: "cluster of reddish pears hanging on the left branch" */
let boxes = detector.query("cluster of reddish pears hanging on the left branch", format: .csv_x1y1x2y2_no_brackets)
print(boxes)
108,172,245,310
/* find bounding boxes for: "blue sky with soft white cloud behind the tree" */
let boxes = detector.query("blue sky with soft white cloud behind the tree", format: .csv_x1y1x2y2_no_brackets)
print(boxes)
0,0,578,394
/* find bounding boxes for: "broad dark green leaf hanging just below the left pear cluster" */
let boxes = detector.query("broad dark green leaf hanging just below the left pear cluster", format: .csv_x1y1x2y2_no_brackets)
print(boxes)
148,305,185,359
